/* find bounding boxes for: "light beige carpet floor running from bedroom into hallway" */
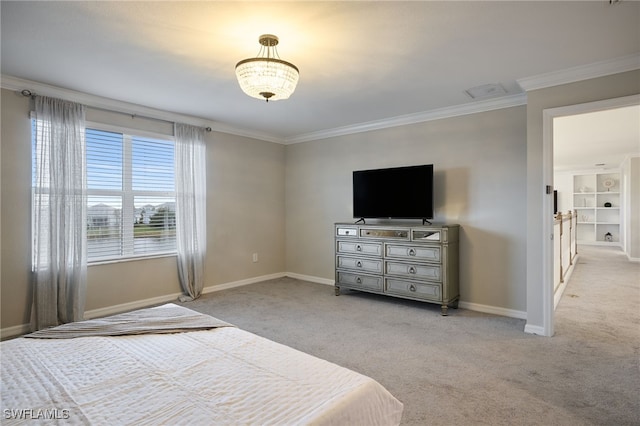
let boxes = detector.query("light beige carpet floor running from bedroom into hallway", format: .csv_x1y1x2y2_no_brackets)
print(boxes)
182,246,640,426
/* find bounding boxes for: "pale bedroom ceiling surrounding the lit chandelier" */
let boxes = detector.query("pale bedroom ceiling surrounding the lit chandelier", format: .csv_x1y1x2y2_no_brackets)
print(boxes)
0,0,640,166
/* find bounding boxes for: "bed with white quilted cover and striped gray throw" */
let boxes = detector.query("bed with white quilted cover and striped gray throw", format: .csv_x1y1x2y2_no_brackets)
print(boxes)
0,304,403,425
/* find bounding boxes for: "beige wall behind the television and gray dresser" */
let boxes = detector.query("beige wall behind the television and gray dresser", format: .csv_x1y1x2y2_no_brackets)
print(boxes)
286,106,526,312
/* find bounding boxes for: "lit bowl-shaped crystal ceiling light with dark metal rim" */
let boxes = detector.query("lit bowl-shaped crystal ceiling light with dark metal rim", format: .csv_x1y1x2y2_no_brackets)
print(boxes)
236,34,299,102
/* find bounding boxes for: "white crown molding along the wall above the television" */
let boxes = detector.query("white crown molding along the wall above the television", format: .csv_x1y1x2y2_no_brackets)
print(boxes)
284,93,527,145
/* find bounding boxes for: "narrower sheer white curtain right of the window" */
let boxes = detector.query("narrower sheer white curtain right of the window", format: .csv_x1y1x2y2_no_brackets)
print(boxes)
175,123,207,301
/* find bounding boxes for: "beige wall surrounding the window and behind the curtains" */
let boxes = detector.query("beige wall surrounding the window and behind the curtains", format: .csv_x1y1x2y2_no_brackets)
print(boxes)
0,90,285,328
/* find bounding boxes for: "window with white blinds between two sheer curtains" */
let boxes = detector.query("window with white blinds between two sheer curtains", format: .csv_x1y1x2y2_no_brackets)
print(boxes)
33,120,176,262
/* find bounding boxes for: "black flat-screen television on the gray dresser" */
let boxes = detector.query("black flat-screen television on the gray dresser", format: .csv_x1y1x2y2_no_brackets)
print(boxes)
353,164,433,219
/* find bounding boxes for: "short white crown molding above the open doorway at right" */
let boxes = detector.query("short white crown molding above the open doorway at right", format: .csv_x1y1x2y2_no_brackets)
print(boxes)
516,53,640,92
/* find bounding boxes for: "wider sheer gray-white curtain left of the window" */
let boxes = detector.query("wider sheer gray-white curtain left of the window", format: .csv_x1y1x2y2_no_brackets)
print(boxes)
31,96,87,330
